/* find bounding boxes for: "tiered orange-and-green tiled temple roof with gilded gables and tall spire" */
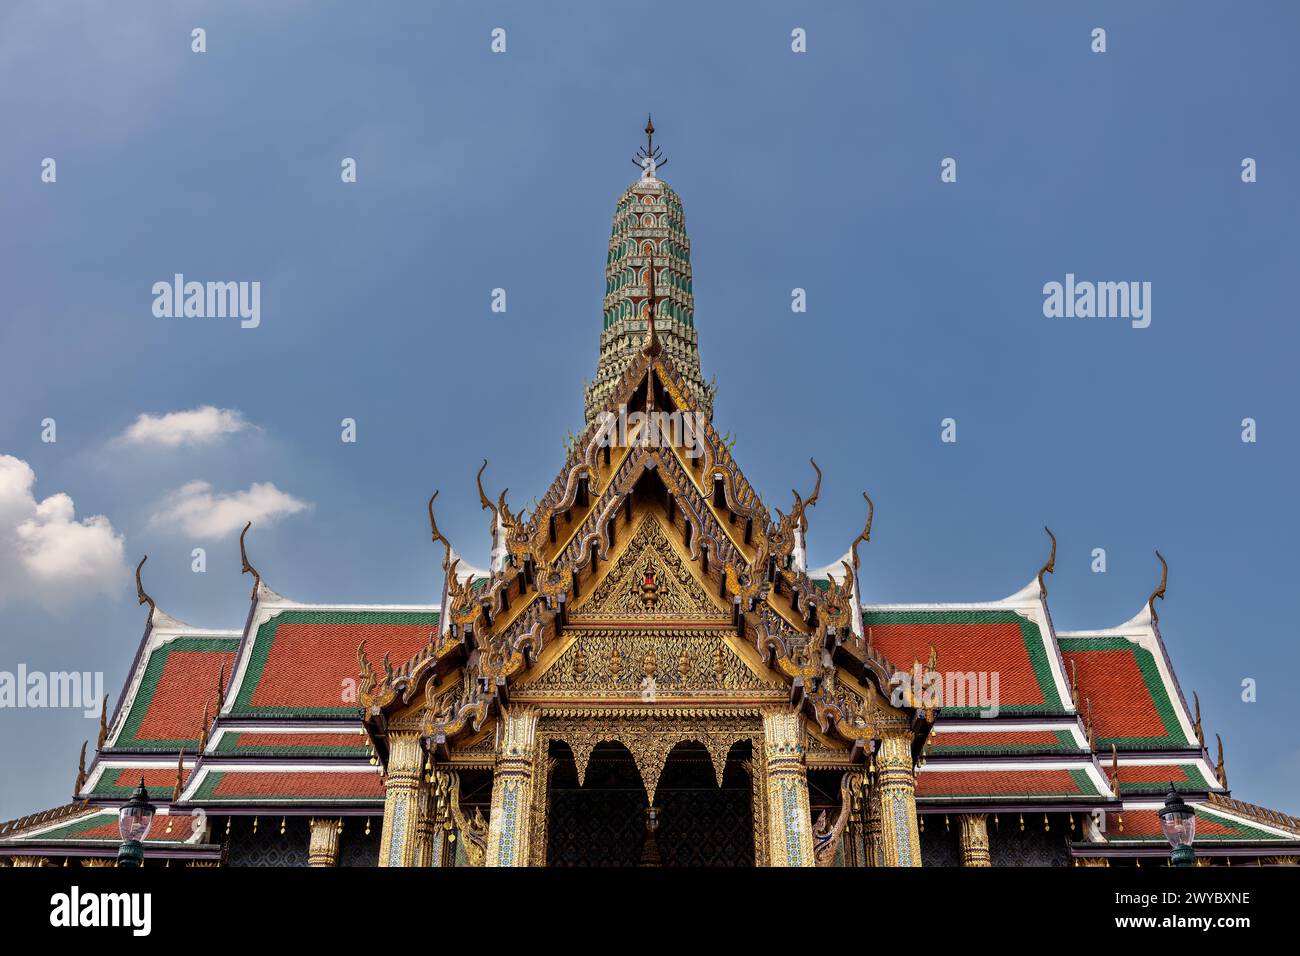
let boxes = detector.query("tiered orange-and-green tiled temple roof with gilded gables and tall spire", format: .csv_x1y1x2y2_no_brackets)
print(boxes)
0,130,1300,860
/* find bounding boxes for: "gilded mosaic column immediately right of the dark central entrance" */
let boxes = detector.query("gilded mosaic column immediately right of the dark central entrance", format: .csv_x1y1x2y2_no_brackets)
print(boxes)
763,711,816,866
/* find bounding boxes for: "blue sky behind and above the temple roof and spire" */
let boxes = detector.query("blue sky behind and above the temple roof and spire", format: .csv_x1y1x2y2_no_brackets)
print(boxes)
0,0,1300,818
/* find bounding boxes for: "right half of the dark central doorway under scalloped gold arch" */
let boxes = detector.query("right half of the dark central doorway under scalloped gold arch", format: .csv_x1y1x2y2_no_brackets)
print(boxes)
655,740,754,866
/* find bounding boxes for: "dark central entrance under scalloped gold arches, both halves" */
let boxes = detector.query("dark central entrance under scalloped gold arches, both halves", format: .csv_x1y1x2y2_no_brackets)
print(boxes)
546,741,754,866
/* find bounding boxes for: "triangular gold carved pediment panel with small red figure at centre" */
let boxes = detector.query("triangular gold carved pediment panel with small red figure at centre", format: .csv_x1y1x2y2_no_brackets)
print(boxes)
572,515,731,624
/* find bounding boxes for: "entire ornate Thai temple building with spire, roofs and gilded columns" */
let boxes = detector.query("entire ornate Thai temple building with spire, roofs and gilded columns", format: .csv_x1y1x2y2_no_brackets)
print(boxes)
0,125,1300,866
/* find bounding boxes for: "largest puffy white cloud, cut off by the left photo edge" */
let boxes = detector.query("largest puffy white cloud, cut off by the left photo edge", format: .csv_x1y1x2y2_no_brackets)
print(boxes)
0,455,127,606
